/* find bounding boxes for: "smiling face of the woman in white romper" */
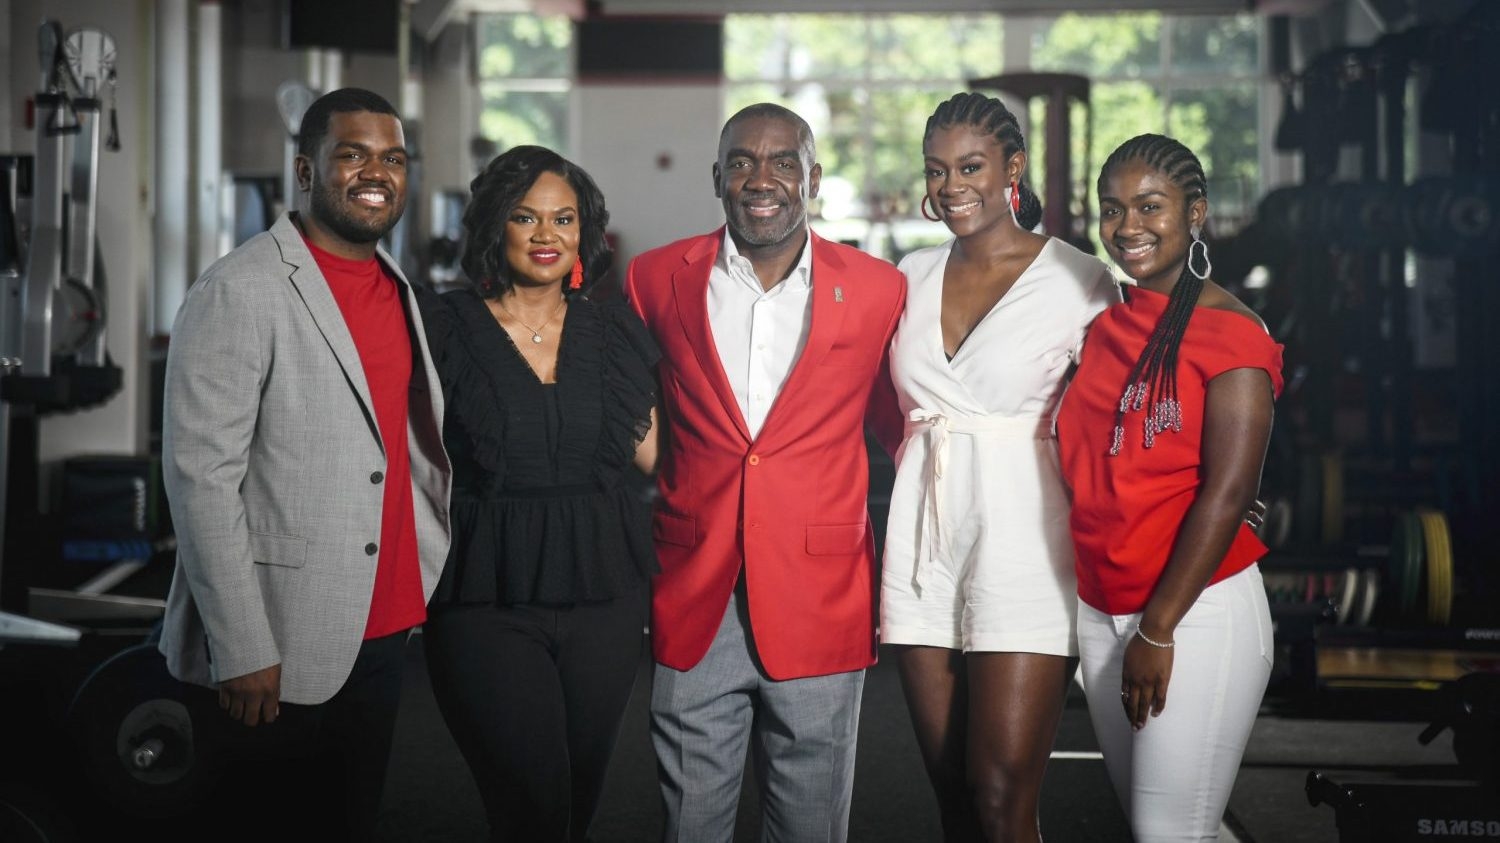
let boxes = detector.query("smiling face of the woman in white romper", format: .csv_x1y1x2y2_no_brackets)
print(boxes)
923,125,1026,237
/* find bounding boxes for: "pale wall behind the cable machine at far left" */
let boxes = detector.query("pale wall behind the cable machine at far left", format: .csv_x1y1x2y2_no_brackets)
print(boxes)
0,0,153,480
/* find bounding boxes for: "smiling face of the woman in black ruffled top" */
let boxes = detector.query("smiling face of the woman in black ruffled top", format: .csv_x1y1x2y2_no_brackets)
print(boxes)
506,173,582,287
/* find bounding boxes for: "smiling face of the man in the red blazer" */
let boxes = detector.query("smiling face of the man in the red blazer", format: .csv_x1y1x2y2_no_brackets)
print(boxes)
714,117,824,252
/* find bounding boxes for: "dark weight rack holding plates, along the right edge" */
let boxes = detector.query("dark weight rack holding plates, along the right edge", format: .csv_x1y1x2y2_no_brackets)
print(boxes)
1257,3,1500,840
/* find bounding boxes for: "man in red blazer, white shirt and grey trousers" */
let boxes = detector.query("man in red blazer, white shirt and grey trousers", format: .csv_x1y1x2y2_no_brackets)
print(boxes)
626,104,905,843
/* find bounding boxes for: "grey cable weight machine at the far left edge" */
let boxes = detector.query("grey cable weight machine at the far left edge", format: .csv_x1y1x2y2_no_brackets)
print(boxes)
0,21,123,644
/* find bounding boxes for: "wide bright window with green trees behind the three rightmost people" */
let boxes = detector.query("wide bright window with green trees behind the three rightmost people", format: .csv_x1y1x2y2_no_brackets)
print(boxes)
725,14,1266,243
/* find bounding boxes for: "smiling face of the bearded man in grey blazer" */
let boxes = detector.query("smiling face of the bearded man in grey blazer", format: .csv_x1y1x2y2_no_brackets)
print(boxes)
296,111,407,255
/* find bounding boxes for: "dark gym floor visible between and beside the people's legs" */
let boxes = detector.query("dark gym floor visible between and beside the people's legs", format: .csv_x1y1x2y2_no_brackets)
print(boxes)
380,630,1458,843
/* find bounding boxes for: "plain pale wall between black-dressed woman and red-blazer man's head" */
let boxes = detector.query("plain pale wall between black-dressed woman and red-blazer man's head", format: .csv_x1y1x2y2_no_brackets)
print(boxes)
573,83,725,270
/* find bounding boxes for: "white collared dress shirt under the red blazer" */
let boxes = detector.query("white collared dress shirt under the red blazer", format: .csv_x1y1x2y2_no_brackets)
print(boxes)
708,230,813,438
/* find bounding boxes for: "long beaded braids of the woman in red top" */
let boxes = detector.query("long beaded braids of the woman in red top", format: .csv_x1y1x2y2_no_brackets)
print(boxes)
1098,135,1209,456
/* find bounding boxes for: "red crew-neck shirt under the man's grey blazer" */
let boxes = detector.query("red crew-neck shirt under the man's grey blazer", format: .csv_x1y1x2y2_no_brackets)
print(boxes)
308,242,428,641
